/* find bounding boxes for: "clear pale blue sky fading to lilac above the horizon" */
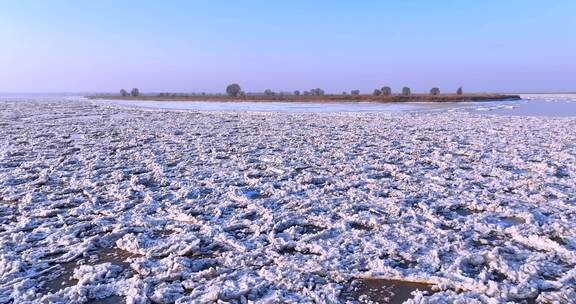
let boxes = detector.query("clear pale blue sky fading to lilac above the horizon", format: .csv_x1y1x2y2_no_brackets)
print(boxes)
0,0,576,93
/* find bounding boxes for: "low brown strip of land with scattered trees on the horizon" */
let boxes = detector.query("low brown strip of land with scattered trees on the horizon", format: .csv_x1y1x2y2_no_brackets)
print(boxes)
85,94,522,103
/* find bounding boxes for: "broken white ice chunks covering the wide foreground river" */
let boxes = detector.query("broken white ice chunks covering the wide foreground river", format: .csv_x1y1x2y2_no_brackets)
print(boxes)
0,100,576,303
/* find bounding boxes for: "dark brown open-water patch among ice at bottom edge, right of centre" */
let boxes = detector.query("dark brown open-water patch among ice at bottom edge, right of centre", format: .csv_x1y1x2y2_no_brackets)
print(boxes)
341,279,434,304
